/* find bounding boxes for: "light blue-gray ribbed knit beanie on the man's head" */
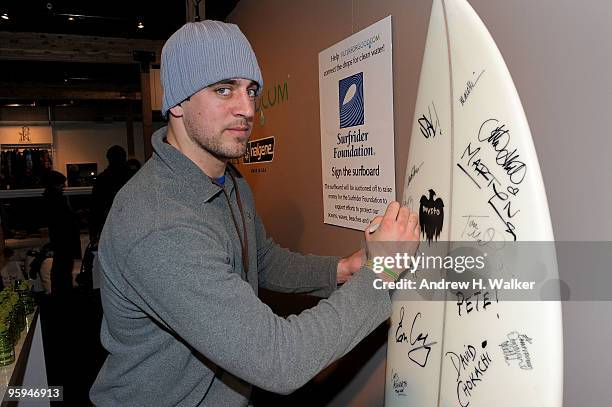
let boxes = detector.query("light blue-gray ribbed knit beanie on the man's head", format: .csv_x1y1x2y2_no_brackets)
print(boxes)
161,20,263,117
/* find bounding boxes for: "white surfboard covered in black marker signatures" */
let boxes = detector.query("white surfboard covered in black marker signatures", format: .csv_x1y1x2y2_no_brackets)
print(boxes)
385,0,563,407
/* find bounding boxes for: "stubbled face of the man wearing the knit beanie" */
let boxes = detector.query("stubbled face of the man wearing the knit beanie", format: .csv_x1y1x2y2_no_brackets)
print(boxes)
181,78,258,160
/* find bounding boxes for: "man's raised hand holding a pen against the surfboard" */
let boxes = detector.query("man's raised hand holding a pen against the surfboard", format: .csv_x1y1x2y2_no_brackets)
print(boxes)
365,202,421,278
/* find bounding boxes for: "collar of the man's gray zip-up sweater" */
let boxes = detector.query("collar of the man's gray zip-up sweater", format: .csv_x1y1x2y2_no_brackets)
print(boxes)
151,126,242,202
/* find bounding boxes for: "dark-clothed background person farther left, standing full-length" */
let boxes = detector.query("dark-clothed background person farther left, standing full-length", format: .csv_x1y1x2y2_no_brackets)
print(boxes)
43,171,81,296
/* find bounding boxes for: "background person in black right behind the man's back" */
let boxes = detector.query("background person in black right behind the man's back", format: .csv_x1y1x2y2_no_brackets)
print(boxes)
89,145,133,241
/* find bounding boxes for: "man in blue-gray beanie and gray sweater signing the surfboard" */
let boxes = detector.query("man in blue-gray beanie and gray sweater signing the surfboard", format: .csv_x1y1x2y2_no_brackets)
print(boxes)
91,21,419,407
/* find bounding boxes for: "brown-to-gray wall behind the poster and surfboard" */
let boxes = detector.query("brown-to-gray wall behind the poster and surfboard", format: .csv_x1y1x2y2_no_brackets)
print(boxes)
229,0,612,406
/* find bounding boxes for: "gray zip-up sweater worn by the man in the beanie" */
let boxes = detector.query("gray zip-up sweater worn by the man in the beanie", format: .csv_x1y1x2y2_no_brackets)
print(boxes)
90,128,391,407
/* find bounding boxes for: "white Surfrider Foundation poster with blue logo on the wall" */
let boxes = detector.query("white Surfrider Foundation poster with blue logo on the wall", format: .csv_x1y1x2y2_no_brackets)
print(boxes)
319,16,396,230
